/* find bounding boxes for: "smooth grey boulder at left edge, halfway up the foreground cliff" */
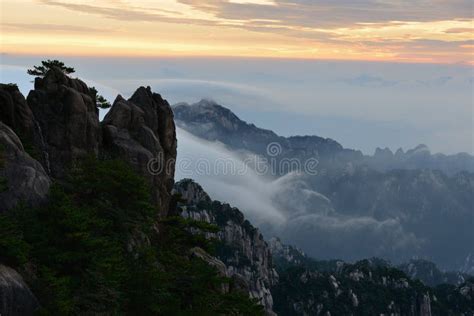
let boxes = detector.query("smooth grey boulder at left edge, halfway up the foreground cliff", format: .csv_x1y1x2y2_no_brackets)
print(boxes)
0,122,51,213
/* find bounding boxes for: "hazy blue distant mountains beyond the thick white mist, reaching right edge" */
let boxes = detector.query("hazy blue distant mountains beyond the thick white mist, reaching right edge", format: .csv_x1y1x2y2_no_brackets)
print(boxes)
173,100,474,270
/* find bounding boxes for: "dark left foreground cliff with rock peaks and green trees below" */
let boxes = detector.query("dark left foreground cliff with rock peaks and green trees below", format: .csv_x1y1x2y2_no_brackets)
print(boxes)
0,67,262,316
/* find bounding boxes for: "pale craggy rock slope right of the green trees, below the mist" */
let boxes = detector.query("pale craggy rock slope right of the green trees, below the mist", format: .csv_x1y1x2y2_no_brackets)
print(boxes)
174,179,278,314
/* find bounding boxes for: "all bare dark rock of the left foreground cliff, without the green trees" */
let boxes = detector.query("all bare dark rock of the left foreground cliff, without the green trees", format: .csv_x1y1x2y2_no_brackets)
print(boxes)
0,67,176,315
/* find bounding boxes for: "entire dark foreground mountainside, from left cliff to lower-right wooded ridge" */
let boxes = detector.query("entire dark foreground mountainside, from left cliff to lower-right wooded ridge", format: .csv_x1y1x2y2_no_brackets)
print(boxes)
0,67,474,316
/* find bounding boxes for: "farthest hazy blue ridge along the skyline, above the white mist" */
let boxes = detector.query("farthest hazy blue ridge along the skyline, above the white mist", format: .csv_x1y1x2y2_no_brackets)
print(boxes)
172,99,474,175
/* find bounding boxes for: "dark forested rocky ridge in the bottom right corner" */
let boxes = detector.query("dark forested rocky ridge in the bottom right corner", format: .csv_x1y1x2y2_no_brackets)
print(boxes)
270,239,474,316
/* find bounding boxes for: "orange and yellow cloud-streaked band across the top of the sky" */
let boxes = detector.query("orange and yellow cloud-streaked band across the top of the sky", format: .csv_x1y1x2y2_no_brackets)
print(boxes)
0,0,474,64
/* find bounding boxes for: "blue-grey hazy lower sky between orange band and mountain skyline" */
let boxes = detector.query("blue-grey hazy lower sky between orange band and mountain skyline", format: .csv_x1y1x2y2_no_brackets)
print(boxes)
0,55,474,154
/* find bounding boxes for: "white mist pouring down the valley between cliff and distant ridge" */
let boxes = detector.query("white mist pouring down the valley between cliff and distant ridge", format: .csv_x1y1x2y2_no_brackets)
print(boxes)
176,128,424,261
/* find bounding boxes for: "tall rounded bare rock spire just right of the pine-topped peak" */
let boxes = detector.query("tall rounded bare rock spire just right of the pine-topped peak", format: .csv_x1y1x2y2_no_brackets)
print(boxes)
102,87,177,216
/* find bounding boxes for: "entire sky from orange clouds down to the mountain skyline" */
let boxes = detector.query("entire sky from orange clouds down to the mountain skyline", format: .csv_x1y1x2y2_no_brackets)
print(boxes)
0,0,474,154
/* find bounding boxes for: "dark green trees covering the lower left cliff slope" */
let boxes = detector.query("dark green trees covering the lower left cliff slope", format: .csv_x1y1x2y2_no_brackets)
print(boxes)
0,158,263,315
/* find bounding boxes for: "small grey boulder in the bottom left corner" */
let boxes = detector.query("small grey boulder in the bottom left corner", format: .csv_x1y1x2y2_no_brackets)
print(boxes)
0,264,39,316
